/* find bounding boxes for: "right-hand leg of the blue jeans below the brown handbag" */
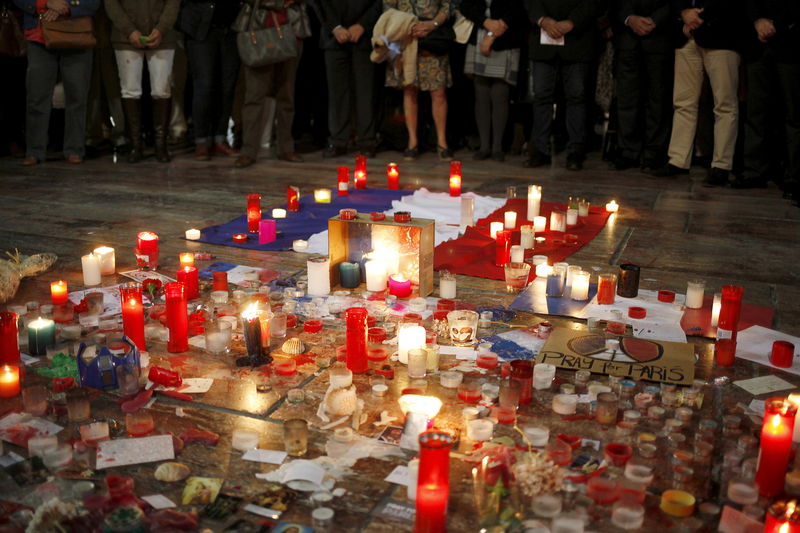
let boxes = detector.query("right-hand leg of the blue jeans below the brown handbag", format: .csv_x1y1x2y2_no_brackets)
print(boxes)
60,50,93,158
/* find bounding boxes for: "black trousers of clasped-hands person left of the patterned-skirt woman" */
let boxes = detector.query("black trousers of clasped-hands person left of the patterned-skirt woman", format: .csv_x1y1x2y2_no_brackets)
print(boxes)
325,45,376,148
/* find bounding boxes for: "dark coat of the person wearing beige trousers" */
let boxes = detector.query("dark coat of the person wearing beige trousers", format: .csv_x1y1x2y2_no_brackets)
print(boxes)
673,0,748,51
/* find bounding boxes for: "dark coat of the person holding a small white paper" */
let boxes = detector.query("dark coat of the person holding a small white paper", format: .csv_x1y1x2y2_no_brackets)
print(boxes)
525,0,600,61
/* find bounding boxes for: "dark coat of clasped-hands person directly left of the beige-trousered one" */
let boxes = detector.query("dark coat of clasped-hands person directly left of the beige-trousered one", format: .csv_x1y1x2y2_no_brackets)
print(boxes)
609,0,675,53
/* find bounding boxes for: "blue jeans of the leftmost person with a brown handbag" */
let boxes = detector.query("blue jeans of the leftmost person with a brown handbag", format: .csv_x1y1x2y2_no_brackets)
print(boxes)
25,41,92,161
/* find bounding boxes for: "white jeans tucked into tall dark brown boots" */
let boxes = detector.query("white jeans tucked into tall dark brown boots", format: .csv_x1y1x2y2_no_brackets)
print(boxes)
114,50,175,98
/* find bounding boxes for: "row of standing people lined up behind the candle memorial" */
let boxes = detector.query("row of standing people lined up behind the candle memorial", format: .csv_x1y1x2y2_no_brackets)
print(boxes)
0,0,800,200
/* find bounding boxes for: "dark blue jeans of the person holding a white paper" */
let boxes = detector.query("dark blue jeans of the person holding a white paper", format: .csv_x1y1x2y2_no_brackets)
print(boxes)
531,60,589,156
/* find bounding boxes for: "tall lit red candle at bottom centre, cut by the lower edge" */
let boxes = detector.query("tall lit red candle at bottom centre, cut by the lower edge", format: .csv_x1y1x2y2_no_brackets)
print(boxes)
414,431,453,533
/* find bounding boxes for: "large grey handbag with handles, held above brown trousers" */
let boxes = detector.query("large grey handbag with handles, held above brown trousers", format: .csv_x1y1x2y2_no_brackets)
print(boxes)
236,0,298,67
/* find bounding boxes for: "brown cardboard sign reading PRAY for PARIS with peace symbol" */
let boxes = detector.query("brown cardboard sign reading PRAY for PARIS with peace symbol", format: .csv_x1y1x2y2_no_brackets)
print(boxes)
536,328,695,385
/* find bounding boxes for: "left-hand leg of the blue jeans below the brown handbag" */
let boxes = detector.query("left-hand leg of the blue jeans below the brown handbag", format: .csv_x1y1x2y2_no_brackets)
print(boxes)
23,41,58,160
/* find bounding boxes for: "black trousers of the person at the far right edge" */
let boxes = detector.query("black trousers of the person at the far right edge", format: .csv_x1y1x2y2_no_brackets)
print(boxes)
744,51,800,183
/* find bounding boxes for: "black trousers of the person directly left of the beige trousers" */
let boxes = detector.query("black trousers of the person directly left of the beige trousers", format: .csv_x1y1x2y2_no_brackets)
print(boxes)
616,48,675,167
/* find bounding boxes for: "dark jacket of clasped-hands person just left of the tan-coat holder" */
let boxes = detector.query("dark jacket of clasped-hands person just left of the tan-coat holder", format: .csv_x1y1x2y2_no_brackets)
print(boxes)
314,0,383,50
